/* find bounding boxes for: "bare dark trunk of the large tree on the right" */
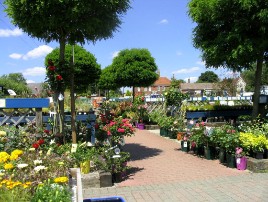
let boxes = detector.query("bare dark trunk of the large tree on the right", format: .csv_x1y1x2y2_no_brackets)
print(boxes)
252,53,263,118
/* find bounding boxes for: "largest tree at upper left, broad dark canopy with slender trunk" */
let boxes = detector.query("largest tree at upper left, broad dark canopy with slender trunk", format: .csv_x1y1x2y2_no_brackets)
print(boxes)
5,0,130,143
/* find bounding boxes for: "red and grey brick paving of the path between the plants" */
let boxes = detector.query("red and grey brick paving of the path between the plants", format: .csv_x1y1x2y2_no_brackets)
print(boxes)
83,130,268,202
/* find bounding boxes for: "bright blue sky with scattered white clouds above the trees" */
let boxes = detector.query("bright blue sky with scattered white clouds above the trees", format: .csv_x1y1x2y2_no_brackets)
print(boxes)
0,0,230,82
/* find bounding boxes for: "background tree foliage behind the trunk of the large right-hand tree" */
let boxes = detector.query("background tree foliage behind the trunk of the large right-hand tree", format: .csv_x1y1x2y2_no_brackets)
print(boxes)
241,64,268,91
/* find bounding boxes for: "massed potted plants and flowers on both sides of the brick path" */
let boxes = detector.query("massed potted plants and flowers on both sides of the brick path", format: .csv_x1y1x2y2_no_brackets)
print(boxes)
0,86,268,201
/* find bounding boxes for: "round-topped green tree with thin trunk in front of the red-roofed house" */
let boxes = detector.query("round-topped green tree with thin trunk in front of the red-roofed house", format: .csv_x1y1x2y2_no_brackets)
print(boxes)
111,48,159,101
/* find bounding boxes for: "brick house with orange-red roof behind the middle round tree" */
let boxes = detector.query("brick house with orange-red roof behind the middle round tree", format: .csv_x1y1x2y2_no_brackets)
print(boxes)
135,77,171,96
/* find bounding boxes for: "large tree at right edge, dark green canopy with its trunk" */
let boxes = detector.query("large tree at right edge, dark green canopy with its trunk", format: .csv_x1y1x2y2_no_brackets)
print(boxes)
188,0,268,117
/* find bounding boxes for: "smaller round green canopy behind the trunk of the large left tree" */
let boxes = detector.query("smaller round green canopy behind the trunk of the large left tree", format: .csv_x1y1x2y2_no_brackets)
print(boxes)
45,45,101,93
